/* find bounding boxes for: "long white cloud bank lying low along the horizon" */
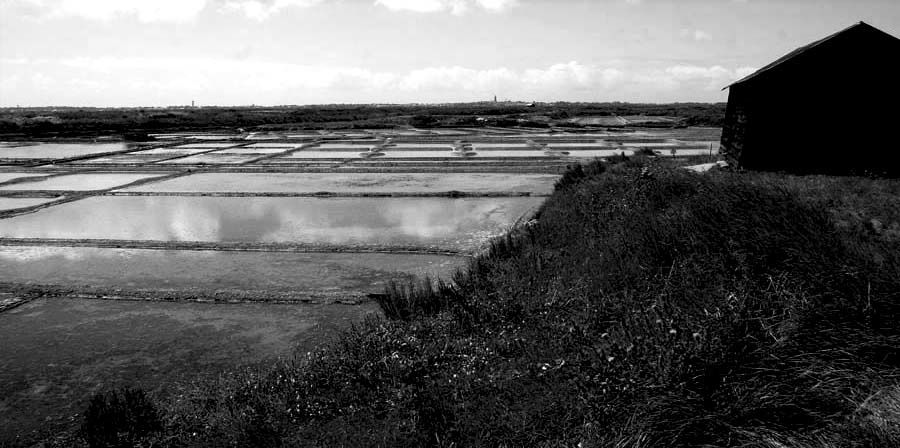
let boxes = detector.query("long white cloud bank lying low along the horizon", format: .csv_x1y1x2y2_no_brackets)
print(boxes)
0,57,753,106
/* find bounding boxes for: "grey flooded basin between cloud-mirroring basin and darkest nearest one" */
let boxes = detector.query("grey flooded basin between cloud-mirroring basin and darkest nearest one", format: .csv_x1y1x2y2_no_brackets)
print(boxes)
0,246,468,300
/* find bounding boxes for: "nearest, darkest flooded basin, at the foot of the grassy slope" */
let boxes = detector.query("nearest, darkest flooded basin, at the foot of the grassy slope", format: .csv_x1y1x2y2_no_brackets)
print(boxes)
0,298,376,446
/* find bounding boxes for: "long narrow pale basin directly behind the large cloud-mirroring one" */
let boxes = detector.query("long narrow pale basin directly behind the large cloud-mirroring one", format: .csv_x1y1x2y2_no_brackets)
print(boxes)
116,173,559,195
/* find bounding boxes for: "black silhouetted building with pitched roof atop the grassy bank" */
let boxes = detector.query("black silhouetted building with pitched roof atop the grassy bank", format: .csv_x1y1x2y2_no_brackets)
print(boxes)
721,22,900,175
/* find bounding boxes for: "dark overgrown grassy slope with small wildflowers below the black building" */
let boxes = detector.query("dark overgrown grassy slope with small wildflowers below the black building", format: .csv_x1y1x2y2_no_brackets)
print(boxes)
100,163,900,447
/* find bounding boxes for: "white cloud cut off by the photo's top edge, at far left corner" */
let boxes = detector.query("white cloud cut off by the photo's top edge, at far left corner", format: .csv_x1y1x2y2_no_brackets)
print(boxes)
0,0,323,23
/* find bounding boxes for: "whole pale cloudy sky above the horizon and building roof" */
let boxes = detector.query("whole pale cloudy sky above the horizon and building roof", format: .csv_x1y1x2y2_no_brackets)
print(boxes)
0,0,900,107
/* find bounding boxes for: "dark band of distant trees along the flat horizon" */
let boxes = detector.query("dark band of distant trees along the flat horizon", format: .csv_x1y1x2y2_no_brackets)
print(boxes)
0,103,725,138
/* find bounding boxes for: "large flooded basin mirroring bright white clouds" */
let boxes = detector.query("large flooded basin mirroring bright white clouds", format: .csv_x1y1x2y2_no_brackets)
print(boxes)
0,196,543,250
